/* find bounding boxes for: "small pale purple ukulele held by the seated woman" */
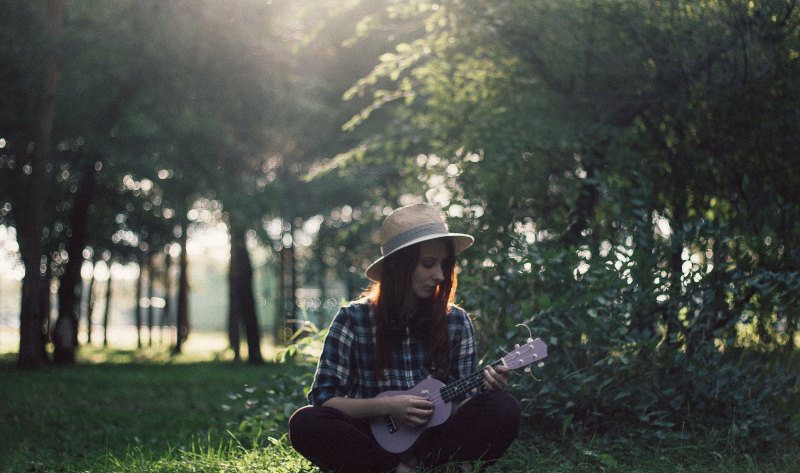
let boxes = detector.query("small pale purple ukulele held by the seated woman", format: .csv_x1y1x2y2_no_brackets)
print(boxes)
370,338,547,453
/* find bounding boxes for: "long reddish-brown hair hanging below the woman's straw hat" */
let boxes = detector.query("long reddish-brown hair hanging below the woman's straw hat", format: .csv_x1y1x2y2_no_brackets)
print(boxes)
364,238,457,379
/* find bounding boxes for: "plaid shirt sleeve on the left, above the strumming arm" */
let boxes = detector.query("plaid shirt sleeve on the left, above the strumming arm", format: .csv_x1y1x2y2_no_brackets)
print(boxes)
308,308,355,406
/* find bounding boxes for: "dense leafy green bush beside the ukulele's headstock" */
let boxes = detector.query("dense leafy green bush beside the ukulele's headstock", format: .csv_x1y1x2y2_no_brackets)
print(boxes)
460,240,800,448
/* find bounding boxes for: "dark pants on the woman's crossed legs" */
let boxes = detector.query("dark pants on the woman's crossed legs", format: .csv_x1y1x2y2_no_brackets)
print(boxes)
289,391,520,473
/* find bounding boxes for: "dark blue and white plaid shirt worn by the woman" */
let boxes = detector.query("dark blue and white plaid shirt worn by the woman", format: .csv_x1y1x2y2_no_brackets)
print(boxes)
308,301,478,406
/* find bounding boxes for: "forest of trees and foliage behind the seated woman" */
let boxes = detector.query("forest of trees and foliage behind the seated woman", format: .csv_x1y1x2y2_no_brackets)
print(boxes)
0,0,800,470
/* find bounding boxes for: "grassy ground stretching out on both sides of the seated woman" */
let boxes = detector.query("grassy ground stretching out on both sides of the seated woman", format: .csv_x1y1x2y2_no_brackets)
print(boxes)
0,349,800,473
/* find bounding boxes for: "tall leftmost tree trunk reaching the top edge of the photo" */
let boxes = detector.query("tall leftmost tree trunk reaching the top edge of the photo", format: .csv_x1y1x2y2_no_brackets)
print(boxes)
15,0,64,368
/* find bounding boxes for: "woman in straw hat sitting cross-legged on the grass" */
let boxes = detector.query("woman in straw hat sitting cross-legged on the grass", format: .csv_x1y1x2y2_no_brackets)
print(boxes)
289,204,520,472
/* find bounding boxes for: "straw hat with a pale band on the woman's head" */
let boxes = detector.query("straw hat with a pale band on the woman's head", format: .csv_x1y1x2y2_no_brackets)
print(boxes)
367,204,475,281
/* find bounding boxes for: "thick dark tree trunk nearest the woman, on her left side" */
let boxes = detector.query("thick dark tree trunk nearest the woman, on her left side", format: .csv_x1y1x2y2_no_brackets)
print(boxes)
229,225,264,364
